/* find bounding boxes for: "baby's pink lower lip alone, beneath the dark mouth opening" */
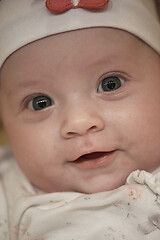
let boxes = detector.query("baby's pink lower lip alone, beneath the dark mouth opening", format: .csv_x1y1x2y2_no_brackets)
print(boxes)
74,151,116,169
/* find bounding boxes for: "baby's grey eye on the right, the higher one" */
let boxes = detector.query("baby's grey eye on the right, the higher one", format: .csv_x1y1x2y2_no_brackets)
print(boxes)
98,76,124,92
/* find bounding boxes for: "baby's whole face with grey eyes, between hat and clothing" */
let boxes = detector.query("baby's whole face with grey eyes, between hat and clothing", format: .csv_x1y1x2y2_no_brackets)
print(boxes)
0,28,160,193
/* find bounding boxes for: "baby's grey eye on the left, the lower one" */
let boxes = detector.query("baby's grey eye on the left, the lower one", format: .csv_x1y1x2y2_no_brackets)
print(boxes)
28,96,53,111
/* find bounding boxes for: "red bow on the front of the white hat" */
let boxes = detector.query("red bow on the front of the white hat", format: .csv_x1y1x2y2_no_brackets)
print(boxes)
46,0,109,12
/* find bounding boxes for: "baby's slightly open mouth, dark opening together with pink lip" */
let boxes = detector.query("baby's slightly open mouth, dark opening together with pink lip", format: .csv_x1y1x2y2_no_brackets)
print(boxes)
74,150,116,169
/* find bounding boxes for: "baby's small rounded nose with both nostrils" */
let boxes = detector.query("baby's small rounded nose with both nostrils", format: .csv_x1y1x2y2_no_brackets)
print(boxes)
61,101,104,139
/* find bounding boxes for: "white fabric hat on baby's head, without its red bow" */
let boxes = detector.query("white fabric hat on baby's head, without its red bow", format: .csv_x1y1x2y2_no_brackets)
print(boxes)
0,0,160,67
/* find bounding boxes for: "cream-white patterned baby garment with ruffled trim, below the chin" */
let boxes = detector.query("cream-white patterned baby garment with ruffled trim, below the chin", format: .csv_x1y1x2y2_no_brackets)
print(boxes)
0,146,160,240
